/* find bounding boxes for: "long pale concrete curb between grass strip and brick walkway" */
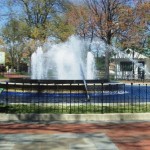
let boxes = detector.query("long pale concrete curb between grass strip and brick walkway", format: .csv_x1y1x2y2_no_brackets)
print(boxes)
0,113,150,122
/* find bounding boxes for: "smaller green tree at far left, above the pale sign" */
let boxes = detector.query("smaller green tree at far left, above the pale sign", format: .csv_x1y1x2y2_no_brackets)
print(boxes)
2,18,27,71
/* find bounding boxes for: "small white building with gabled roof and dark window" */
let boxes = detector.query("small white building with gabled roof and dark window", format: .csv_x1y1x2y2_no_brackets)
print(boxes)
113,49,150,79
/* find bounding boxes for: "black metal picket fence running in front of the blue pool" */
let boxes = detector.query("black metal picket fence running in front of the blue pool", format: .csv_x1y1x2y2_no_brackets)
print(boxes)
0,80,150,113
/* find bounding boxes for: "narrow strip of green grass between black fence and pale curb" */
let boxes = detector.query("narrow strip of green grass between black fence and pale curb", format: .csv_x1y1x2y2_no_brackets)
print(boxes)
0,104,150,114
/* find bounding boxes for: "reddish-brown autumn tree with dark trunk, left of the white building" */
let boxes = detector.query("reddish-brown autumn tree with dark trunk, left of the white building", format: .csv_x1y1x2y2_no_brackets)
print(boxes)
67,0,148,80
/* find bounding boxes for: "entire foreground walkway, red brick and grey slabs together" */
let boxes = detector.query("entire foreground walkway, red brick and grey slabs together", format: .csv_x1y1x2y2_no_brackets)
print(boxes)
0,122,150,150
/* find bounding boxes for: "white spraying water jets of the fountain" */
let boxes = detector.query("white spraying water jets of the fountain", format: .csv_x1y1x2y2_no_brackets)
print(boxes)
31,36,95,80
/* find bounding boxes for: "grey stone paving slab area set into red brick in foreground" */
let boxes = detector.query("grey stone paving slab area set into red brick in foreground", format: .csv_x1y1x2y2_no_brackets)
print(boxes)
0,133,118,150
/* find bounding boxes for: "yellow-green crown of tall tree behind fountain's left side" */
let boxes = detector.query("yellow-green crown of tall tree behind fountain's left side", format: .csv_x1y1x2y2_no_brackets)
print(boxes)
14,0,70,41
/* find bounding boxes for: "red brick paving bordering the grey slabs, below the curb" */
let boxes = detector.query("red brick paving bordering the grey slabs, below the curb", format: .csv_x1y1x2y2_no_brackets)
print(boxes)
0,122,150,150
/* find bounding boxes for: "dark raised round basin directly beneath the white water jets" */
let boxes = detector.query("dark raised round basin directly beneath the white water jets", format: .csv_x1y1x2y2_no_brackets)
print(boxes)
1,78,123,93
